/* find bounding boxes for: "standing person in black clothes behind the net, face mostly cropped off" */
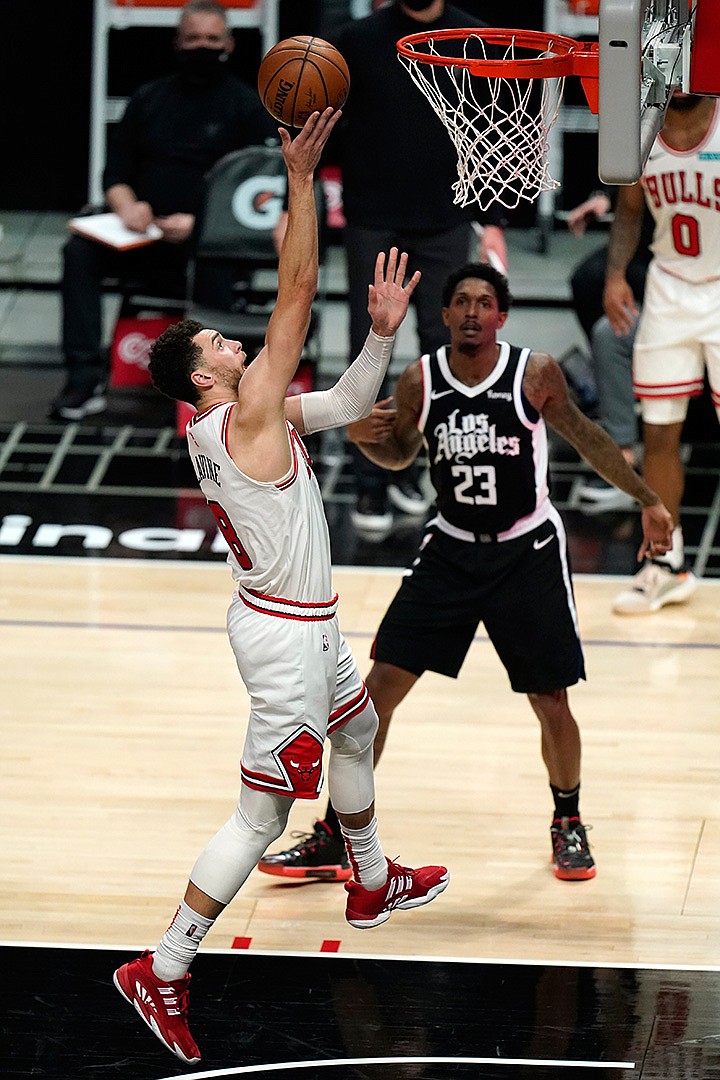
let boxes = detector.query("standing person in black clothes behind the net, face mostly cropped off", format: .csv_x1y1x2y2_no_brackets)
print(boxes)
328,0,507,539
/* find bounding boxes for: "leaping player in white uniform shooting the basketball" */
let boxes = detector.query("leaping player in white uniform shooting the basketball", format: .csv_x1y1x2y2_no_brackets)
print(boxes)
114,109,448,1063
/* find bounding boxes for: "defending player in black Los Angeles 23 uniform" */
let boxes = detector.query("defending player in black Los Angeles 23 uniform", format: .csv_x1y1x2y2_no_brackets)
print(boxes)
259,264,673,880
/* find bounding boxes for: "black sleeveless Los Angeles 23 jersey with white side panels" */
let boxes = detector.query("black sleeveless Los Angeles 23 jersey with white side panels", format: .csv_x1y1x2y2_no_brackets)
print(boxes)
418,341,549,539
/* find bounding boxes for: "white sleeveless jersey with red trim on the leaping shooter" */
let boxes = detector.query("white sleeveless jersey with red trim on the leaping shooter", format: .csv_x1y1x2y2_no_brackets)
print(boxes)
187,403,335,605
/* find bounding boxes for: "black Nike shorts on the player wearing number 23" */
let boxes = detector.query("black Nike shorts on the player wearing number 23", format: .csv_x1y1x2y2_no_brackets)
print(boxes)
370,509,585,693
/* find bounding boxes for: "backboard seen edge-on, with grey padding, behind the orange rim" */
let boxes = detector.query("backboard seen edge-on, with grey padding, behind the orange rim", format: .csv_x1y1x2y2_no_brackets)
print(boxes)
598,0,720,184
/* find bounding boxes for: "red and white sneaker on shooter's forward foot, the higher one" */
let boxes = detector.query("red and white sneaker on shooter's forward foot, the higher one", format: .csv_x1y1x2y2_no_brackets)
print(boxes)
345,859,450,930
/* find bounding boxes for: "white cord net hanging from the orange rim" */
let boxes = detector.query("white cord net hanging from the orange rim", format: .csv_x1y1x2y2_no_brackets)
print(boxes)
398,35,565,210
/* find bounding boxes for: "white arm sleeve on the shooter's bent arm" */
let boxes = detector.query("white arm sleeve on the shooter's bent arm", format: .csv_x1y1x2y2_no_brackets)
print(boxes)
300,330,395,435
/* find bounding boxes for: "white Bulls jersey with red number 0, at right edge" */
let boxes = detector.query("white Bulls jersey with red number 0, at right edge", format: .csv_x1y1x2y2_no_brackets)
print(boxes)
642,104,720,283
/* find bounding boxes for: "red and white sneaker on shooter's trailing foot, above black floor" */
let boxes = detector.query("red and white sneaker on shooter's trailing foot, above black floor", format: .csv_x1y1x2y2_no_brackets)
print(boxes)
112,949,200,1065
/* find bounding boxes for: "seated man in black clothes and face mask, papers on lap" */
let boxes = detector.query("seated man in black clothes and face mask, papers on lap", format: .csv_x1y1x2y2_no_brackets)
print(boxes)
50,0,279,421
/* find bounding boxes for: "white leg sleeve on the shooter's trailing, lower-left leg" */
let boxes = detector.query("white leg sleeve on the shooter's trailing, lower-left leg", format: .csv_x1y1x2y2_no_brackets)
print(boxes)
190,785,293,904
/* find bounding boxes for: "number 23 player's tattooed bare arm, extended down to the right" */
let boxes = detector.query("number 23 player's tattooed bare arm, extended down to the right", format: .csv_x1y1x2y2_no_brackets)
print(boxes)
522,352,673,562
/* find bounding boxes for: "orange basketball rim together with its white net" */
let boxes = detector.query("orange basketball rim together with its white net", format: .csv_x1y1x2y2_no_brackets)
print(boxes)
397,28,598,210
